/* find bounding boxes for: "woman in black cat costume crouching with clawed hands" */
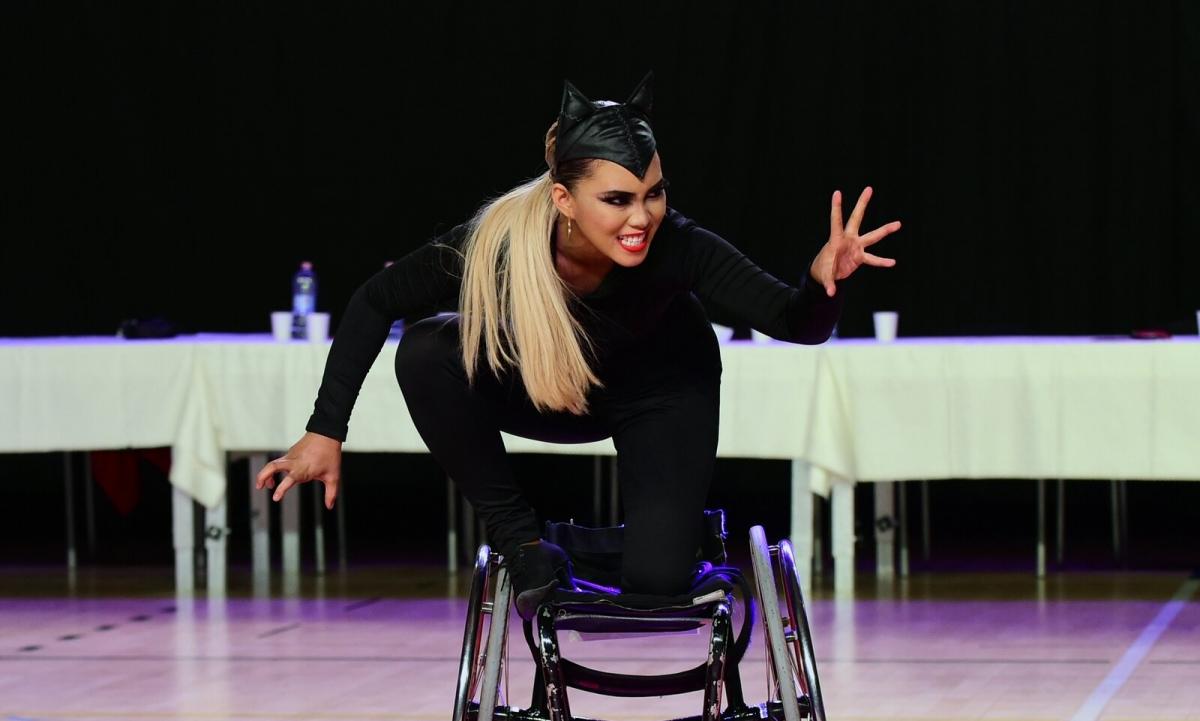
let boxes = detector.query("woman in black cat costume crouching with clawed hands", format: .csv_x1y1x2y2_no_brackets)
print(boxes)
258,76,900,618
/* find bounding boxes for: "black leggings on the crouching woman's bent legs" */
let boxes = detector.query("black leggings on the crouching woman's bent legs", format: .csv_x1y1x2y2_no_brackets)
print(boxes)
396,317,720,594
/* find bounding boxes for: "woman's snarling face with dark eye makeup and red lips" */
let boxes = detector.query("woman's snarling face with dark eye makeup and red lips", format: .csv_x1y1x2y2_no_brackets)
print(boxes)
556,154,667,268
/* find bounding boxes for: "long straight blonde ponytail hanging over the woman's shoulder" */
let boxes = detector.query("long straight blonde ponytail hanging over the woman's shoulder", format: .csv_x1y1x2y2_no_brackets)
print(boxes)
458,122,601,415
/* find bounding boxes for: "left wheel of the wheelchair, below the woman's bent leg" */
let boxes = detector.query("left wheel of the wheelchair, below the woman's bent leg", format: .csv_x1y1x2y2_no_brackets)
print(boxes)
452,546,511,721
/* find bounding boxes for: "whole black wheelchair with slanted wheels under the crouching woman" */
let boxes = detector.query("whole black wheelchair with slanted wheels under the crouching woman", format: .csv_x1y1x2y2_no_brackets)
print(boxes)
452,510,826,721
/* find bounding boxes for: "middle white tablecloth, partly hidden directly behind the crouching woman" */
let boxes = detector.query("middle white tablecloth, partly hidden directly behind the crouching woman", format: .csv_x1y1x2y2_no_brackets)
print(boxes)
194,336,817,504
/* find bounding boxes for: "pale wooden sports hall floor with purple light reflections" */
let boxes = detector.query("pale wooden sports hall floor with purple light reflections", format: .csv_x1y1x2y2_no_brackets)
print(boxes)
0,567,1200,721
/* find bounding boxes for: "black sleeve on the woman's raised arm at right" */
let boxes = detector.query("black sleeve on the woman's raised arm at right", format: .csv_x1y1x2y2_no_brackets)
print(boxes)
679,226,845,344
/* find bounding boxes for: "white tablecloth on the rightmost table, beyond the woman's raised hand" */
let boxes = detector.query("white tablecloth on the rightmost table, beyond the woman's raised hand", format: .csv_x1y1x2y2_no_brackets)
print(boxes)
799,336,1200,481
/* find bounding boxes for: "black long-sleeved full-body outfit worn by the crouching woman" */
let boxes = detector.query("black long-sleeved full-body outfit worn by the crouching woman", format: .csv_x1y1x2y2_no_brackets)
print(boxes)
307,205,842,594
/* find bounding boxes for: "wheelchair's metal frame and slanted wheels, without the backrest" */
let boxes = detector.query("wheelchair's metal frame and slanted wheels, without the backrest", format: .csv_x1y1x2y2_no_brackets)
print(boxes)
452,525,826,721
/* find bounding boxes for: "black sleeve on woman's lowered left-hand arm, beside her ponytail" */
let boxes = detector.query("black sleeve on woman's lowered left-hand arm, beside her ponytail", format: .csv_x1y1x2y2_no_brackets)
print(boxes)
305,226,466,440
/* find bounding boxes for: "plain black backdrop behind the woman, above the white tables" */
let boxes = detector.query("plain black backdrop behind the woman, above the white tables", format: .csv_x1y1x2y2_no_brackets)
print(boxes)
0,0,1200,335
